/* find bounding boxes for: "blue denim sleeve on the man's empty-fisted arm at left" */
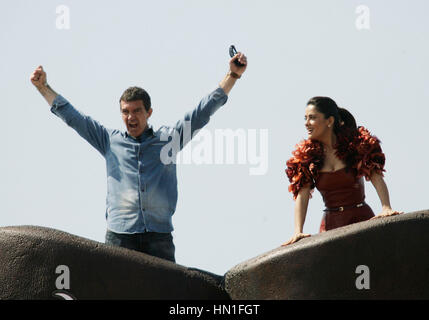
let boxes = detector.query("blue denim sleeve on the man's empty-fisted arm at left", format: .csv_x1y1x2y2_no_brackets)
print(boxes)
51,95,109,156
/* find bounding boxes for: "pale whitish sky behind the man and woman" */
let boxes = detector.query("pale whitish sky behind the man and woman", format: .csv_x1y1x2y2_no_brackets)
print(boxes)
0,0,429,274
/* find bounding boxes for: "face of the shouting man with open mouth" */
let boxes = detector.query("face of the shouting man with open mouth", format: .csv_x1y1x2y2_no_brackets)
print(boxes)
121,100,152,138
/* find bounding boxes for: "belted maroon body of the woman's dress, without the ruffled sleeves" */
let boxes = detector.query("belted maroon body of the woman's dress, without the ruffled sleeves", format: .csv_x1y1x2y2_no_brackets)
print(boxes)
316,168,374,232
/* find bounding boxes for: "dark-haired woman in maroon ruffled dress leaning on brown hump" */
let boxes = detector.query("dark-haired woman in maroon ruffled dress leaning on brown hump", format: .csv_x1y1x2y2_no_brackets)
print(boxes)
283,97,402,245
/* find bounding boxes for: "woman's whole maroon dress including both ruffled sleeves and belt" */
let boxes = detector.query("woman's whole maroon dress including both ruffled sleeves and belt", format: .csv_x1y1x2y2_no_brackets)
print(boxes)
285,127,385,232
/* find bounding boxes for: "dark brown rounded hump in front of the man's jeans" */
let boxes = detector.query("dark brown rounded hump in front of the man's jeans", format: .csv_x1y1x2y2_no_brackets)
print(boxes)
0,226,229,300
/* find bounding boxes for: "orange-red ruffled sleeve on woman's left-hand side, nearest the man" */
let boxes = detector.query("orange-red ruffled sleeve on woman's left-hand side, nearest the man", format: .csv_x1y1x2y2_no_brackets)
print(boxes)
285,139,323,200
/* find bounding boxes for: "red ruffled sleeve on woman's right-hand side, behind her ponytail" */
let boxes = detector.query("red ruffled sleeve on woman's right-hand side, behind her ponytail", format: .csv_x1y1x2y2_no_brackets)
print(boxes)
354,127,386,180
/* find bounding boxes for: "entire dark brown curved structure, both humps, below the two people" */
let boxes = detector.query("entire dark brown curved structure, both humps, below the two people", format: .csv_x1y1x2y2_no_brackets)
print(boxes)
0,211,429,300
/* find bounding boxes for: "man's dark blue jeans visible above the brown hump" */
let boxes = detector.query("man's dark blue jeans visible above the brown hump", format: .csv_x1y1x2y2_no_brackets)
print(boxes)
105,230,176,262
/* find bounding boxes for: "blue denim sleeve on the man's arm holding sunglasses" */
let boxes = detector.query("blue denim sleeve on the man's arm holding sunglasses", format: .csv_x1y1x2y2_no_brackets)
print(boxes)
174,87,228,150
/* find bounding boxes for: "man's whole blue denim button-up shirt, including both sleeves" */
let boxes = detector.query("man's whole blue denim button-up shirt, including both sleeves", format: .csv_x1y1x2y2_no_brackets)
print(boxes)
51,87,228,233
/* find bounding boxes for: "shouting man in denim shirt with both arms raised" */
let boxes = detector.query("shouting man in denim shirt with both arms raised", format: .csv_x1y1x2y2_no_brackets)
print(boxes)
31,52,247,262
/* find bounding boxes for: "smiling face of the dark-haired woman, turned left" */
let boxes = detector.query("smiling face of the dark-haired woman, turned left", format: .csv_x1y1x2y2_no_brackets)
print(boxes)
304,104,334,140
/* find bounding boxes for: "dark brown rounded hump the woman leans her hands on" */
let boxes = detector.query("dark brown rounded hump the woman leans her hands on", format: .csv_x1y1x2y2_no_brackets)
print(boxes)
225,210,429,299
